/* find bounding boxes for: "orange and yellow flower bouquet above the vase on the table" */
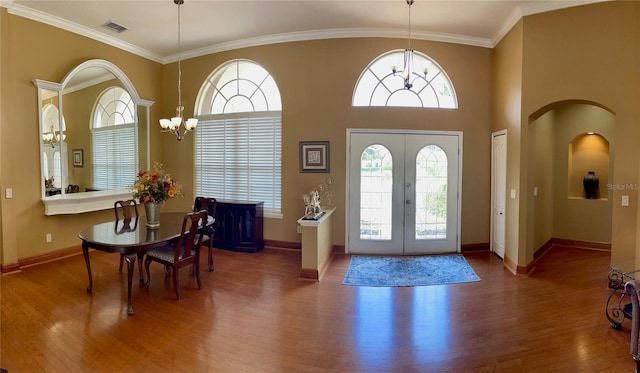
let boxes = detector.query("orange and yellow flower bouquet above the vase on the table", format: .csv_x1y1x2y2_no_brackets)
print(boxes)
131,162,183,205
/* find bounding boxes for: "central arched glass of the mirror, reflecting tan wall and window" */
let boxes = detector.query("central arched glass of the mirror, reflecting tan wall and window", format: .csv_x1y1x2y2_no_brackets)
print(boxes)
62,67,130,192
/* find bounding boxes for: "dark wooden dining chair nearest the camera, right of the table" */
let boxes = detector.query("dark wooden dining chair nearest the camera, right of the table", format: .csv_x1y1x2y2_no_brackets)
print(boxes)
144,210,207,299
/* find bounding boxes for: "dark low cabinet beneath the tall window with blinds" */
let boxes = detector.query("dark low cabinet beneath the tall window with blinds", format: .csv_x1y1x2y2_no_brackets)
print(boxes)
213,200,264,253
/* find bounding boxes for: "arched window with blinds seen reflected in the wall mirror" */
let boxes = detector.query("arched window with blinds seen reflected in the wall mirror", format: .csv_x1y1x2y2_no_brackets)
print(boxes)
91,87,138,190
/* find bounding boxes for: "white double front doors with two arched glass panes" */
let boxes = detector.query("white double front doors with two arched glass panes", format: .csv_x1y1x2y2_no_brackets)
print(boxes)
346,130,462,255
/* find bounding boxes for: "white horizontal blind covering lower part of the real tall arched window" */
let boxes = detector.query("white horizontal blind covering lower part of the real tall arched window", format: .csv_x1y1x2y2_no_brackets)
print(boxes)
195,112,282,213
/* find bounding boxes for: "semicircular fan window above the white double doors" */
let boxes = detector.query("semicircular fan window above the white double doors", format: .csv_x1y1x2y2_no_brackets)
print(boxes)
352,50,458,109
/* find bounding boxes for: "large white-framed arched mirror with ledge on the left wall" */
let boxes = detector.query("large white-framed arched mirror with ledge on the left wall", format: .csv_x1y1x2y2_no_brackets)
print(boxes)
34,60,153,215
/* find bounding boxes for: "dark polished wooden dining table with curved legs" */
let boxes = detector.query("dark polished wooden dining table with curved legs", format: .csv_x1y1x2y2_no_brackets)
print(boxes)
78,212,213,316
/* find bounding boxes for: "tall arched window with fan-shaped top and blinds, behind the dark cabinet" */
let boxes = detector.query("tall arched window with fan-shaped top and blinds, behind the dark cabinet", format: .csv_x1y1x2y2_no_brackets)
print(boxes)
195,59,282,217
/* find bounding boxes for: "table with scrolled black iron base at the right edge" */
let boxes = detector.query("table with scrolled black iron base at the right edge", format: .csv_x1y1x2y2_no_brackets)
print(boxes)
605,260,640,330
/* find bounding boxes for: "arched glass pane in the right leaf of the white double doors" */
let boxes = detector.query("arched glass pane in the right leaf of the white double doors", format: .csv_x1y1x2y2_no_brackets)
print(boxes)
415,145,448,240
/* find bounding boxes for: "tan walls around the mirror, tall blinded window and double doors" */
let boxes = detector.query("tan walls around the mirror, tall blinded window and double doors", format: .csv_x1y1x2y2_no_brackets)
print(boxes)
0,9,491,264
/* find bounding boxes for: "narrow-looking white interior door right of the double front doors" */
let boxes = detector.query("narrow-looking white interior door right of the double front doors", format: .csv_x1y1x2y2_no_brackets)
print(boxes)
491,131,507,259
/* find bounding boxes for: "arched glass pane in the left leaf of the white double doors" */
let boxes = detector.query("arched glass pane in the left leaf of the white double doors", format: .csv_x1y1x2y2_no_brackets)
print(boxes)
360,144,393,240
